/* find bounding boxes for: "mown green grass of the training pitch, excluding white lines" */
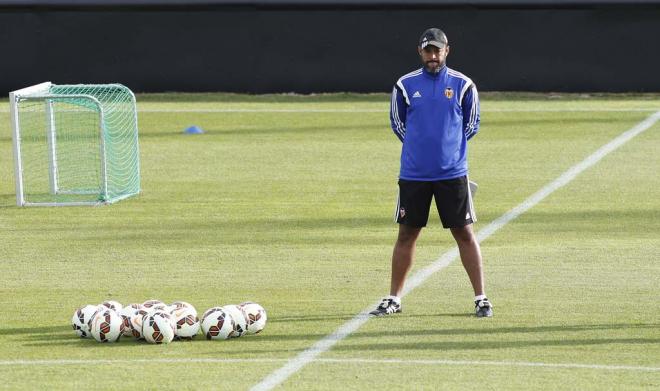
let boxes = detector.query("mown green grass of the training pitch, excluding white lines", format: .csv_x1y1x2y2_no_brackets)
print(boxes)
0,94,660,390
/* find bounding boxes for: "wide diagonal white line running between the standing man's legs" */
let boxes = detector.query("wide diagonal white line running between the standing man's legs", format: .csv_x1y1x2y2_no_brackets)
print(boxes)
252,111,660,391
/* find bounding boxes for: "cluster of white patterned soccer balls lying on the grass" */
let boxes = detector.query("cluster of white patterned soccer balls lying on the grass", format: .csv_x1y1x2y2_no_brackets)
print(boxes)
71,300,266,344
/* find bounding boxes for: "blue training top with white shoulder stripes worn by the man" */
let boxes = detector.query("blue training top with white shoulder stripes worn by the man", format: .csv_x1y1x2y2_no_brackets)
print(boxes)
390,66,479,181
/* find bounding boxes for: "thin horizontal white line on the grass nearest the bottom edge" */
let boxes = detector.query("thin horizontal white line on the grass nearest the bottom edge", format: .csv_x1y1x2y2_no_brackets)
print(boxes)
0,358,660,372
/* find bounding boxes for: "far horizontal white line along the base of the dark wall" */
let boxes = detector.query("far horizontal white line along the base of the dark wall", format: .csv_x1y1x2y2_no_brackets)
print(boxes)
0,108,655,114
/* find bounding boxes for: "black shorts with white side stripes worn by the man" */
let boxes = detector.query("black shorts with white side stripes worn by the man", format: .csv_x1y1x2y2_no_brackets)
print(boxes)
395,176,477,228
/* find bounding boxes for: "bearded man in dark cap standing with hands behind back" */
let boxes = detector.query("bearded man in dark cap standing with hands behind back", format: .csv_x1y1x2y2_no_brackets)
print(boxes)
371,28,493,317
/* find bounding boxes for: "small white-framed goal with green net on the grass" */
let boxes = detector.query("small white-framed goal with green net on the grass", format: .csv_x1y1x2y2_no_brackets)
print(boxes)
9,82,140,206
